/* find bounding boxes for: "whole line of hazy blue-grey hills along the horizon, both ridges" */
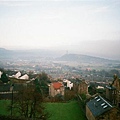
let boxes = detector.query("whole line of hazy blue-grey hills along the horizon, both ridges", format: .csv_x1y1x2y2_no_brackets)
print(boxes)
0,48,116,63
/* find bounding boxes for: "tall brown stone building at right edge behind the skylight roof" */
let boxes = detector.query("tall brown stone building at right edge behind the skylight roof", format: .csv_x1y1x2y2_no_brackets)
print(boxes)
106,75,120,108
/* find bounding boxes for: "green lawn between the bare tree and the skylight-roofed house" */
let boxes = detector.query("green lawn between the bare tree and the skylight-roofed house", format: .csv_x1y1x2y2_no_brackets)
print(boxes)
46,101,86,120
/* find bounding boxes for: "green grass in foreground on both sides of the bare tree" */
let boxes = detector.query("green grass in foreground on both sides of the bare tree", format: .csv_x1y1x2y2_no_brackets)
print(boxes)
0,100,86,120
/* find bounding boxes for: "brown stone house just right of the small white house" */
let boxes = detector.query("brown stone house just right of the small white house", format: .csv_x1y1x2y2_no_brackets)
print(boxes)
78,80,88,94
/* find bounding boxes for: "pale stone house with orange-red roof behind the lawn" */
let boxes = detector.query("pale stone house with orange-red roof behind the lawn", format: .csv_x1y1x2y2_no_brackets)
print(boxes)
49,82,64,97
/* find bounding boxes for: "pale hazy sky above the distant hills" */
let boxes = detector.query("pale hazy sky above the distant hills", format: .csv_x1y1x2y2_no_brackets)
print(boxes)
0,0,120,58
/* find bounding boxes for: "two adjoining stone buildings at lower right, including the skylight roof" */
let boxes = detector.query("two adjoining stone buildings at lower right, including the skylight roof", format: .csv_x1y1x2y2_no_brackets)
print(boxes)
86,75,120,120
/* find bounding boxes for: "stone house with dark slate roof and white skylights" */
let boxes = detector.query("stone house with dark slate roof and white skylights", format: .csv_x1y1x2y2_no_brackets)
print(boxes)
86,95,120,120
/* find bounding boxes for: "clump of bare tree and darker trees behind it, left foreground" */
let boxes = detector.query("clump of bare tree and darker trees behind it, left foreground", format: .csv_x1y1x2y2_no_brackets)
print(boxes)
11,73,49,120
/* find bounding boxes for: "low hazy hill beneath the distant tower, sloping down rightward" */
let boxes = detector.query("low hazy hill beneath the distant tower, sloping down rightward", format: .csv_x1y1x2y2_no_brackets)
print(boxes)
57,54,115,63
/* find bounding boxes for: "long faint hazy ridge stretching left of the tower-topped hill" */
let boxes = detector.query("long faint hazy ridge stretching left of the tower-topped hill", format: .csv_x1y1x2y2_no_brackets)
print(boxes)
0,48,59,60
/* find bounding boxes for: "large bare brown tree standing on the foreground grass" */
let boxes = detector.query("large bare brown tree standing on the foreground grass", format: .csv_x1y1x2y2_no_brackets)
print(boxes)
13,86,47,120
